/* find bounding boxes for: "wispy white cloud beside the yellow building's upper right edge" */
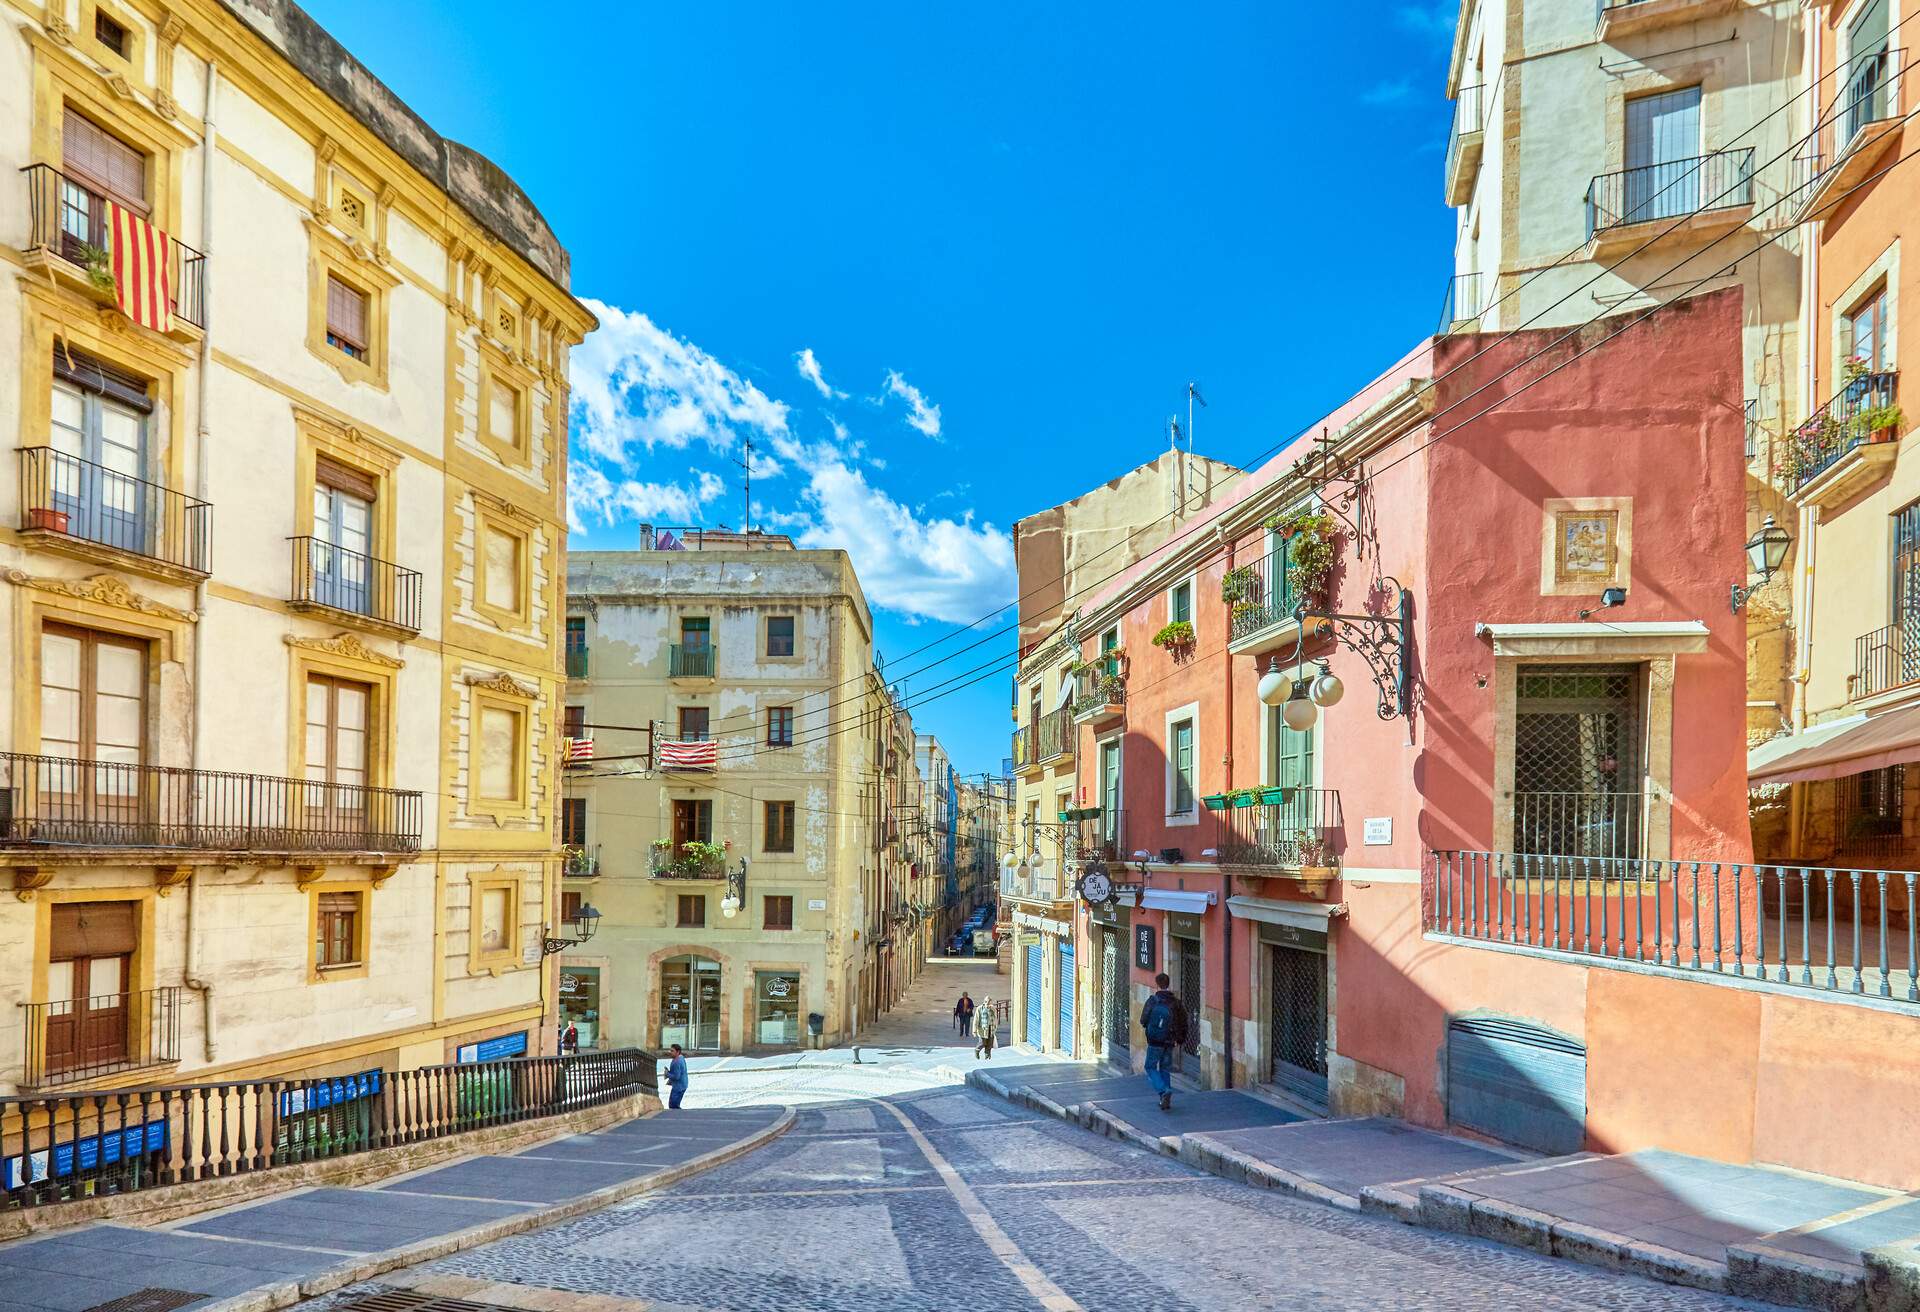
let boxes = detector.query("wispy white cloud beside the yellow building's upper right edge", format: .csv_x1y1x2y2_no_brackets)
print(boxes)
570,300,787,467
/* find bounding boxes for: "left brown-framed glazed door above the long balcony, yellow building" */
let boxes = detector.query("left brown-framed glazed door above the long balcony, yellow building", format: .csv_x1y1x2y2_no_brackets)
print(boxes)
40,624,146,768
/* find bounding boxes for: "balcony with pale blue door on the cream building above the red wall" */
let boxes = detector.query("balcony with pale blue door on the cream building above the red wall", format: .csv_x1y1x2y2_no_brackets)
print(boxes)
1586,148,1753,257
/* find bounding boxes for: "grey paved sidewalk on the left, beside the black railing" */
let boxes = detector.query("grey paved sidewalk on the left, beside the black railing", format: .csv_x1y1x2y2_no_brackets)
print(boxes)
0,1106,791,1312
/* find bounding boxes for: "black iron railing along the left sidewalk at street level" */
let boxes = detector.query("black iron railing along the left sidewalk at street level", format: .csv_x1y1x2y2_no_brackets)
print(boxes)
0,1049,659,1206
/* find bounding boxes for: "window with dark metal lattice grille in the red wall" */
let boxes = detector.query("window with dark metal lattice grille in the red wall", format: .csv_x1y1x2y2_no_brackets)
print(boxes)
1513,665,1645,857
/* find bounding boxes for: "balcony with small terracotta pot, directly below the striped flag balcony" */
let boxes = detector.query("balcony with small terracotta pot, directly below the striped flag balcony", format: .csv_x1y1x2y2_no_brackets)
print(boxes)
19,446,213,582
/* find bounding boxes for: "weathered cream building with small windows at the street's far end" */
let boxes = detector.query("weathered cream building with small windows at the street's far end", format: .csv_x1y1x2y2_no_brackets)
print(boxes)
563,534,879,1051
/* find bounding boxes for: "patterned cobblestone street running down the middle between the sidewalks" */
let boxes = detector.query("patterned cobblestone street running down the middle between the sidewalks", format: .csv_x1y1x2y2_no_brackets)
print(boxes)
317,970,1789,1312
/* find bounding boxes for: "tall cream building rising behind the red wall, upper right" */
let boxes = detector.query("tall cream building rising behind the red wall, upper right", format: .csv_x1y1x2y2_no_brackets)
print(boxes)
1440,0,1804,738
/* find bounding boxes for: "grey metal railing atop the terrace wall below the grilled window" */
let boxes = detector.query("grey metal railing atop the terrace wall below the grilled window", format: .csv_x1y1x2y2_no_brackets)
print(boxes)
1423,851,1920,1003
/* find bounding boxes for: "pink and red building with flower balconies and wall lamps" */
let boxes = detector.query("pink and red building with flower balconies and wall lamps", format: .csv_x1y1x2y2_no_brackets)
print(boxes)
1036,290,1920,1187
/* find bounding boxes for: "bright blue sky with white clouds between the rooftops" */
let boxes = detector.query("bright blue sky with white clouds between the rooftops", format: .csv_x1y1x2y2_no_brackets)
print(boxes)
305,0,1457,772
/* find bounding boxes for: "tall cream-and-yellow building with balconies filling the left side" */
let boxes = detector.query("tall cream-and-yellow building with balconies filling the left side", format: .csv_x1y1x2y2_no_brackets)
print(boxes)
0,0,593,1091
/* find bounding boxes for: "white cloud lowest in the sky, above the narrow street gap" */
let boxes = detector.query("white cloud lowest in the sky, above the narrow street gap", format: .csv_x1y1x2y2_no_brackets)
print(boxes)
799,461,1016,624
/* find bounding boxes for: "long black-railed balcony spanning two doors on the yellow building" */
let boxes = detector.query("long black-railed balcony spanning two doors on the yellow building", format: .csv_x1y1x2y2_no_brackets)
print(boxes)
0,751,422,855
